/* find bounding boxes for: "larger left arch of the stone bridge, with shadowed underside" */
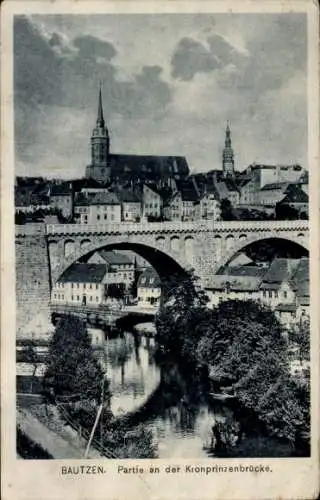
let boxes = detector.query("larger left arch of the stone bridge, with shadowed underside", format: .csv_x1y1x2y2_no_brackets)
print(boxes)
52,237,191,284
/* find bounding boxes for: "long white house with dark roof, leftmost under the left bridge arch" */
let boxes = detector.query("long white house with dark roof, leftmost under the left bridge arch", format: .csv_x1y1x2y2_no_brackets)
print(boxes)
51,263,107,306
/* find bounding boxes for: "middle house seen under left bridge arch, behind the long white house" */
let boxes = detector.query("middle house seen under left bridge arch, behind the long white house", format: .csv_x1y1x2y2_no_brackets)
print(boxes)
88,249,135,290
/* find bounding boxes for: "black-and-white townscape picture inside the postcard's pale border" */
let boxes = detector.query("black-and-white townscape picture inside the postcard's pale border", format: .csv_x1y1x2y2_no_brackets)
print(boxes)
4,2,316,498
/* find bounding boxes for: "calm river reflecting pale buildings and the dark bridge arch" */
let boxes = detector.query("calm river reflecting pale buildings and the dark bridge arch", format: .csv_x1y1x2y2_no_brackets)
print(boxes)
91,330,302,458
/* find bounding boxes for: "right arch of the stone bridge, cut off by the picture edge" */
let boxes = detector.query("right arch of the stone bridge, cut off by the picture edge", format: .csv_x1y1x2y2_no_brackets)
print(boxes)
218,234,309,269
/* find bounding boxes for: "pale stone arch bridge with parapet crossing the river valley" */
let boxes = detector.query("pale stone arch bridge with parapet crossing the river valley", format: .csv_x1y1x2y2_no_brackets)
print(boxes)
46,220,309,287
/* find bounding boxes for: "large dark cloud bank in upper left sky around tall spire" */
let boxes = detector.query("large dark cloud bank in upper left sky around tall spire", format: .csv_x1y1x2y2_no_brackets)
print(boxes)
14,16,171,168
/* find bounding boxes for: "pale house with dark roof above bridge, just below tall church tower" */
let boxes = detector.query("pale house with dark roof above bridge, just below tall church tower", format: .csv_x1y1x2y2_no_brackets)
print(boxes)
74,191,121,224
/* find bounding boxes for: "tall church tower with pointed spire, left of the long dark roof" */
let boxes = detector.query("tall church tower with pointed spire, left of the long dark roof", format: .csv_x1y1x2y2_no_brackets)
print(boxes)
87,87,110,181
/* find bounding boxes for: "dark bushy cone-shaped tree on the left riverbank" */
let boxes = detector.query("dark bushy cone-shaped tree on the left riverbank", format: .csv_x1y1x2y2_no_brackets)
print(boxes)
44,315,108,403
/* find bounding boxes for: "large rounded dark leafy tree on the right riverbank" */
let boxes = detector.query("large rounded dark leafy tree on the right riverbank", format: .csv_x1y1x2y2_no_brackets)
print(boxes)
197,300,310,443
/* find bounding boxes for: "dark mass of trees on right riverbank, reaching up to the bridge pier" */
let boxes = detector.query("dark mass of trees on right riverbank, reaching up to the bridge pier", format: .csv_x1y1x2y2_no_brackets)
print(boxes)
156,276,310,443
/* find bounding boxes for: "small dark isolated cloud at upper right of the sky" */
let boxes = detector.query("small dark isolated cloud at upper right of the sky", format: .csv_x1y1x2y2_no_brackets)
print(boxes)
171,34,244,81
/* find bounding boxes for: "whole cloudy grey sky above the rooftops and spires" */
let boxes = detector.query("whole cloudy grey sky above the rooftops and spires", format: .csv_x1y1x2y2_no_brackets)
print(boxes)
14,13,307,178
